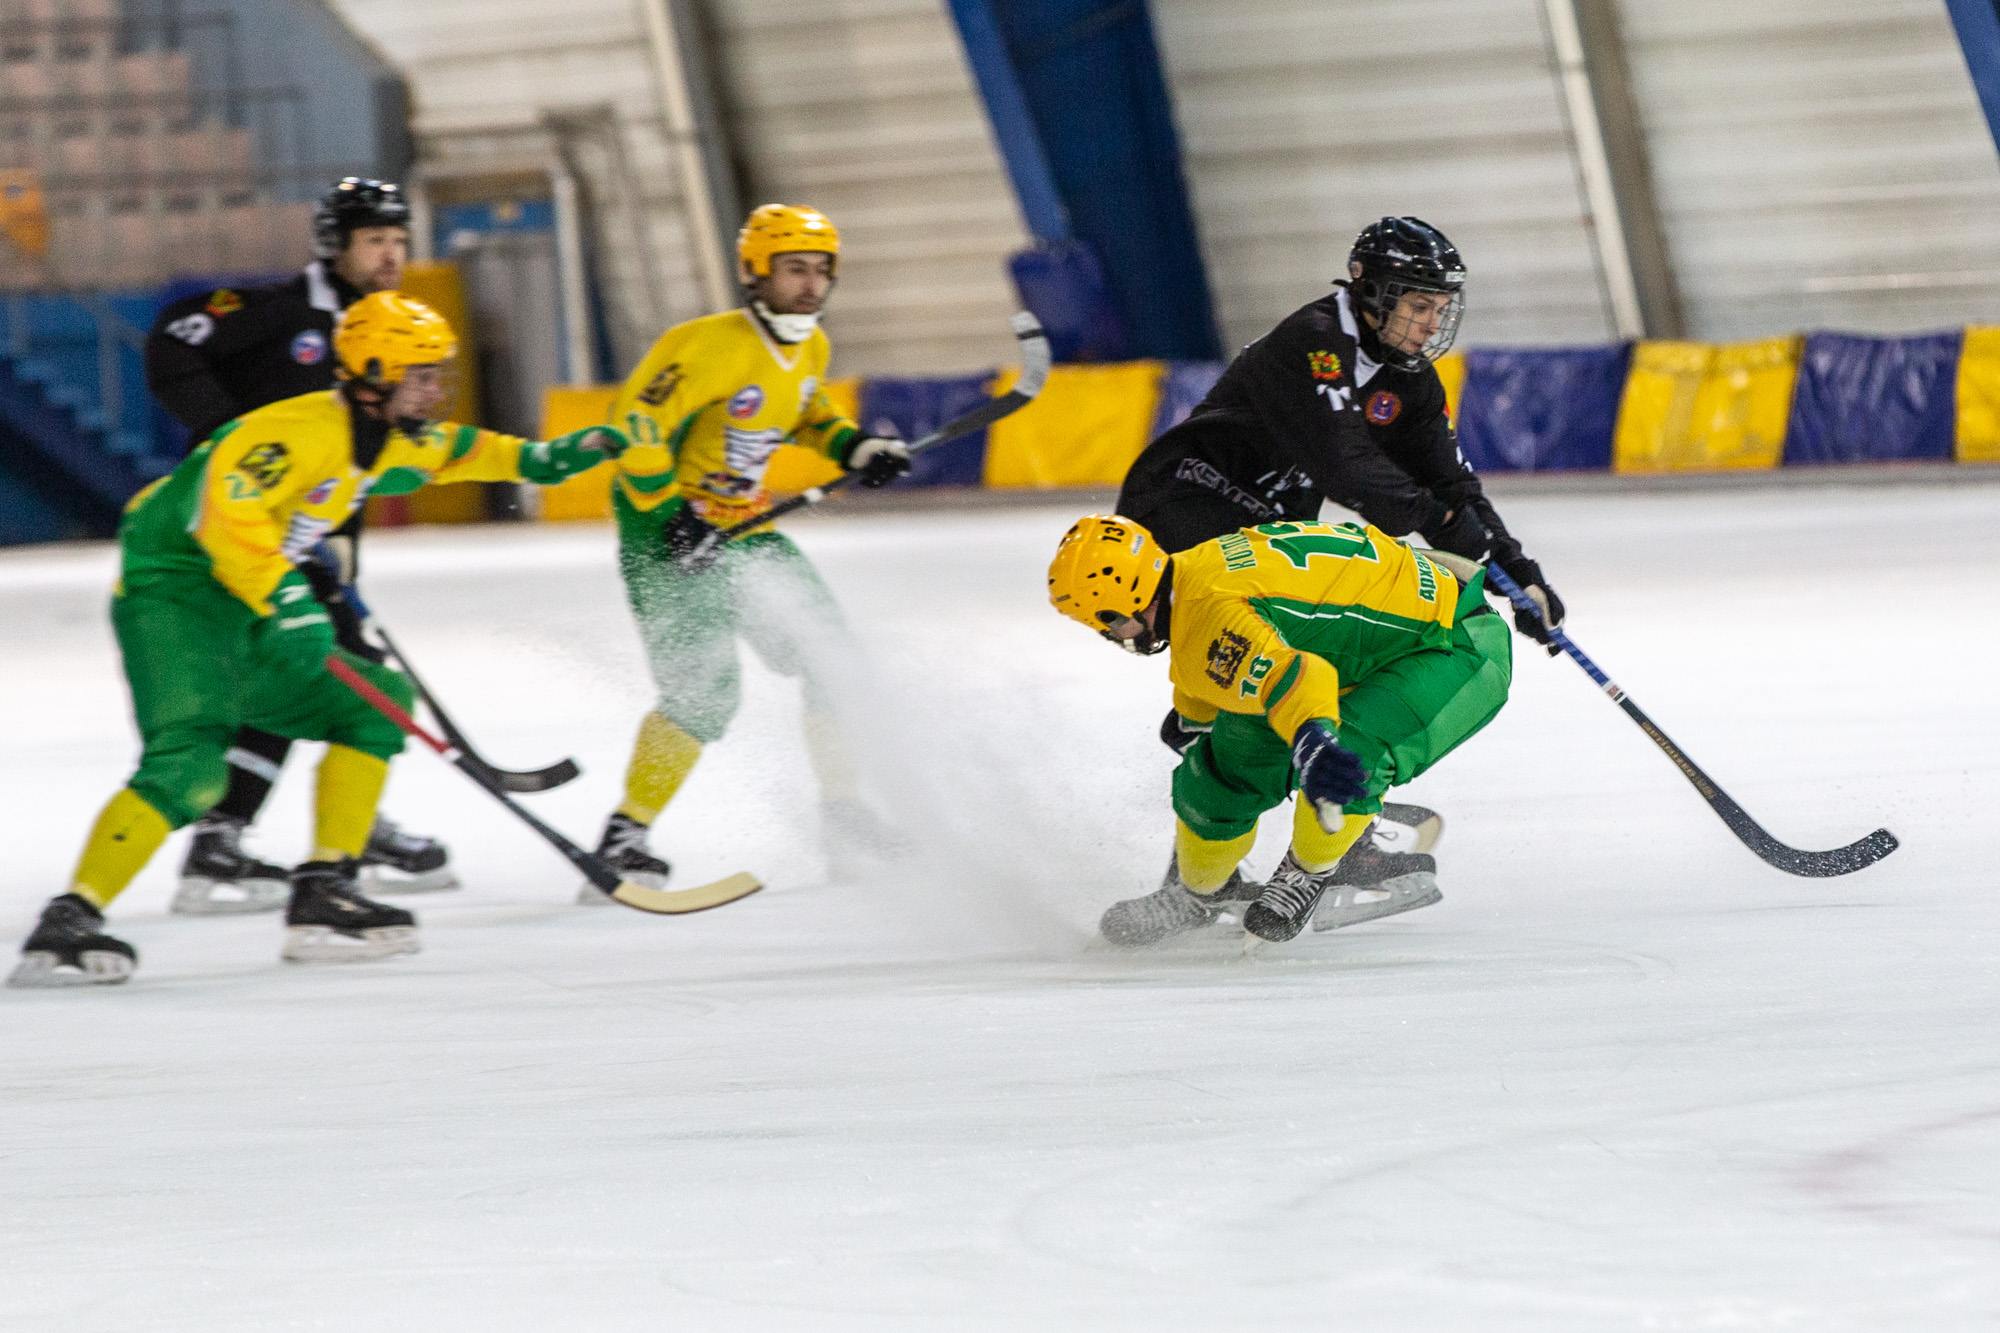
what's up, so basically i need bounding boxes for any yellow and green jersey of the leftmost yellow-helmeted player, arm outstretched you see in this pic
[118,390,576,614]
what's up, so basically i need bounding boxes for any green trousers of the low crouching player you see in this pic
[1174,602,1514,843]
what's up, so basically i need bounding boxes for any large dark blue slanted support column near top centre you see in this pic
[950,0,1222,360]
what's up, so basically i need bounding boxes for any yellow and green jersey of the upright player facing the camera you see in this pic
[612,308,860,536]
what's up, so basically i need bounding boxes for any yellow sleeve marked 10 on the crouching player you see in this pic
[1170,596,1340,743]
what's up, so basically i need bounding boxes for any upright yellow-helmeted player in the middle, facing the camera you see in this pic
[578,204,910,892]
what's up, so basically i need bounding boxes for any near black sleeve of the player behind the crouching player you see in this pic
[1244,306,1444,536]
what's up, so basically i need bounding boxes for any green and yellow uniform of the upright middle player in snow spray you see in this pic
[612,308,860,825]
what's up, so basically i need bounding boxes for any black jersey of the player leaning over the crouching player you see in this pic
[1118,288,1520,562]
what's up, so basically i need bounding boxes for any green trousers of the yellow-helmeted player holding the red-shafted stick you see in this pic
[112,578,414,829]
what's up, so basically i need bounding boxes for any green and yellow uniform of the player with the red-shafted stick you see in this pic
[72,390,600,907]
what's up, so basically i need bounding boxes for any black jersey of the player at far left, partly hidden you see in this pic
[146,260,360,442]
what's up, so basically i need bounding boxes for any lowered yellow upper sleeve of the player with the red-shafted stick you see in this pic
[194,430,310,616]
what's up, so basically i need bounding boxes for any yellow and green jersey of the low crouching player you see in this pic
[1168,522,1462,741]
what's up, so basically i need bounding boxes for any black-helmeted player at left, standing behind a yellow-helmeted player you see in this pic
[146,176,458,913]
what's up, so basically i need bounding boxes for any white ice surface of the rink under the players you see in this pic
[0,472,2000,1333]
